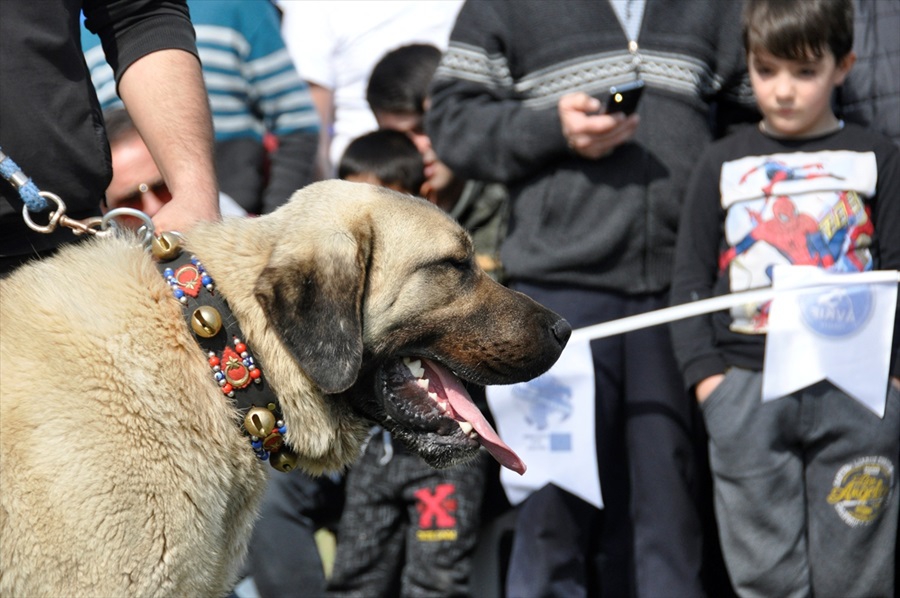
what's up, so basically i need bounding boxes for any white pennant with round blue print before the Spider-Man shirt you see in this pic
[762,266,898,417]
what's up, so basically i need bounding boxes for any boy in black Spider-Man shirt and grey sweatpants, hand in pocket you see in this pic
[672,0,900,597]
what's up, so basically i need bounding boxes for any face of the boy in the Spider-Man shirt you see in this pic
[747,49,855,137]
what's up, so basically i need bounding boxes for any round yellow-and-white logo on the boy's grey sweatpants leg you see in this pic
[828,457,894,527]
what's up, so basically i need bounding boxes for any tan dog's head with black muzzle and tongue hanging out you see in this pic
[206,181,571,472]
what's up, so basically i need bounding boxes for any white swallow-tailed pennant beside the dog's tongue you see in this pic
[487,339,603,508]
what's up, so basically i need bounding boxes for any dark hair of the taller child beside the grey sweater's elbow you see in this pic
[366,44,441,114]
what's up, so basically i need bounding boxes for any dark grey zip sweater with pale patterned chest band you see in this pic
[427,0,756,294]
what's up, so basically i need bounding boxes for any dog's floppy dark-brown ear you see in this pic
[254,220,370,394]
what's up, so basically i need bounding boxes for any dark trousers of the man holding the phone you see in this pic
[507,284,708,598]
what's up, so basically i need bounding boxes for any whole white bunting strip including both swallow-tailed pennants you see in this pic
[487,266,900,508]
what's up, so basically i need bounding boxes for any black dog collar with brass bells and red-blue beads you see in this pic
[152,233,297,472]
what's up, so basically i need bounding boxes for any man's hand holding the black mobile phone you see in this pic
[558,92,640,160]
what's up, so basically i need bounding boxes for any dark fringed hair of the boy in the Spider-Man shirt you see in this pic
[743,0,853,62]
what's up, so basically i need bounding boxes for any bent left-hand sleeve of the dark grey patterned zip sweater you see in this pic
[425,2,568,184]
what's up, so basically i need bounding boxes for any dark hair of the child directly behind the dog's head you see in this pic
[338,129,425,195]
